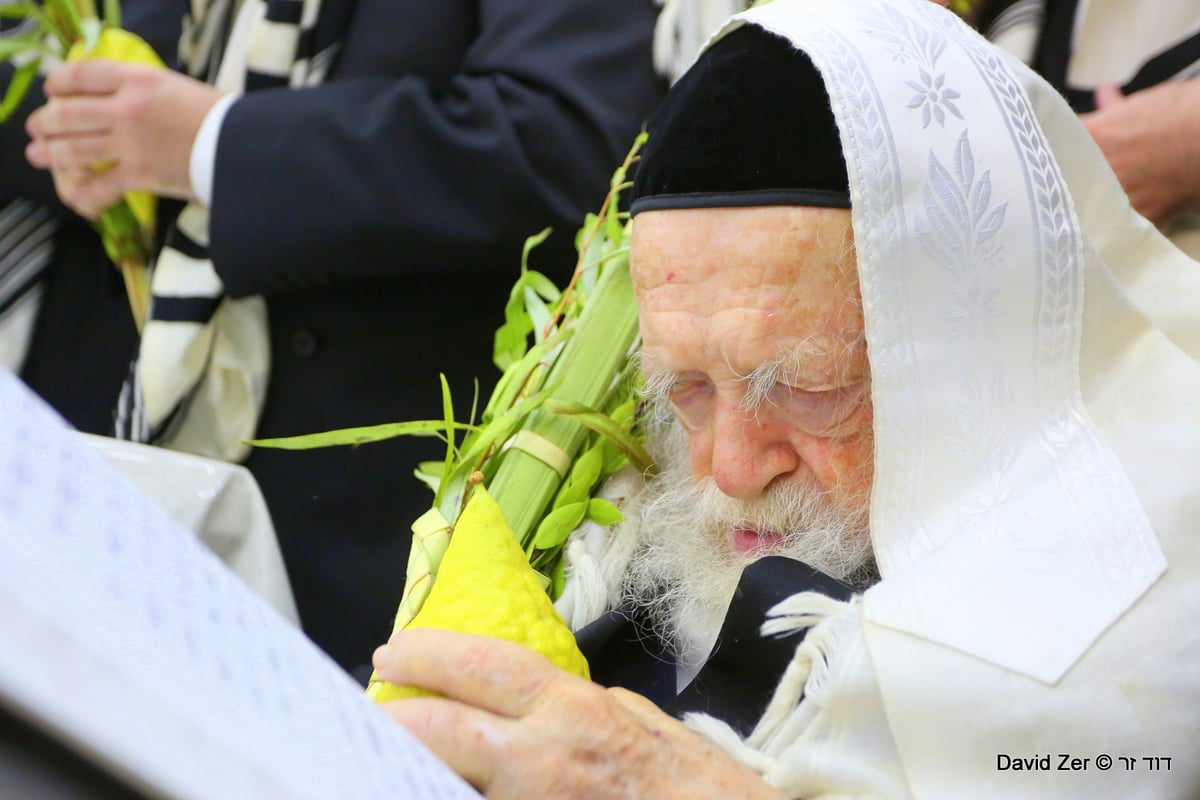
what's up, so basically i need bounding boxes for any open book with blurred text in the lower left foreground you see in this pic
[0,371,479,800]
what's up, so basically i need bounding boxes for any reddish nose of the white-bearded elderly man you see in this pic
[709,401,802,500]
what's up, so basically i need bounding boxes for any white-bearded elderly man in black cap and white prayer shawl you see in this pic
[376,0,1200,799]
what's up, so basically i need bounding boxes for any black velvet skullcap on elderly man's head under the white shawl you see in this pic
[631,24,850,213]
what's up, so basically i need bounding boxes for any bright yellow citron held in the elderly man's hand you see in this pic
[371,486,589,703]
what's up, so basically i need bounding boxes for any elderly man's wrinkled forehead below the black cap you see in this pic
[630,206,865,381]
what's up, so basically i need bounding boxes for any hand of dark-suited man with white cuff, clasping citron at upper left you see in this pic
[25,59,222,219]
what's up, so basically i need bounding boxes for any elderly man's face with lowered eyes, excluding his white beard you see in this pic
[631,207,872,557]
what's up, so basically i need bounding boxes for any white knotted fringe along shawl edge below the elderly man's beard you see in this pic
[684,591,858,798]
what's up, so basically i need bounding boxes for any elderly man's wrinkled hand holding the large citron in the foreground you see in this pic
[374,630,782,800]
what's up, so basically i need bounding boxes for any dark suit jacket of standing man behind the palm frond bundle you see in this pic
[0,0,665,670]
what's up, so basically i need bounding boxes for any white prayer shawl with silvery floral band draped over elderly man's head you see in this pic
[648,0,1200,800]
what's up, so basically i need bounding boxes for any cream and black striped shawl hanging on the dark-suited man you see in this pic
[116,0,320,462]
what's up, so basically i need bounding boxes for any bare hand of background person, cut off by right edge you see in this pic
[1080,80,1200,225]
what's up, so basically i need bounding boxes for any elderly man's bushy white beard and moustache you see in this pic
[622,421,875,670]
